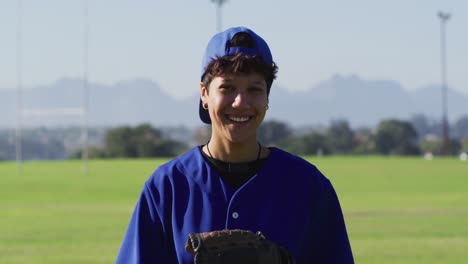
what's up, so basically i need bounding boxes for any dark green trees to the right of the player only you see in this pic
[259,119,468,155]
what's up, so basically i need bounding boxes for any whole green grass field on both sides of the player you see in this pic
[0,157,468,264]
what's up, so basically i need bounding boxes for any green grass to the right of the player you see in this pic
[309,157,468,264]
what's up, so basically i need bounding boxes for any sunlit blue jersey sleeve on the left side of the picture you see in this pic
[116,184,168,264]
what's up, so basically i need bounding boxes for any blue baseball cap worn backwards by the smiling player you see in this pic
[199,27,273,124]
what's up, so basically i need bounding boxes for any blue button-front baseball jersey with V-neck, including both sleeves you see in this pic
[117,147,354,264]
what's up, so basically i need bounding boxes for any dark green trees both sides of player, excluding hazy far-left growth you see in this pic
[85,118,468,158]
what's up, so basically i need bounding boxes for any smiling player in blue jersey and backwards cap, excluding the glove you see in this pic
[117,27,353,264]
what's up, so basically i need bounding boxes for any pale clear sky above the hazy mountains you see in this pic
[0,0,468,98]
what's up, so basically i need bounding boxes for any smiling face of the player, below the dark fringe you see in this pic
[200,73,268,143]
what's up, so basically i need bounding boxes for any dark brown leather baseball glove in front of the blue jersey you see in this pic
[185,229,295,264]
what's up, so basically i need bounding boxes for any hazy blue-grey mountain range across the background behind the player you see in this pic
[0,75,468,128]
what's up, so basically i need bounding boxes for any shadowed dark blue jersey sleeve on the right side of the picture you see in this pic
[320,181,354,264]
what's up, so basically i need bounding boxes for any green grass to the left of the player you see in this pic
[0,160,161,263]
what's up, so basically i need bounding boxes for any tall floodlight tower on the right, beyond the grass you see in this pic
[438,11,450,155]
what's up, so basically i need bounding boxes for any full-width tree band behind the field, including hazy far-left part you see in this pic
[0,115,468,160]
